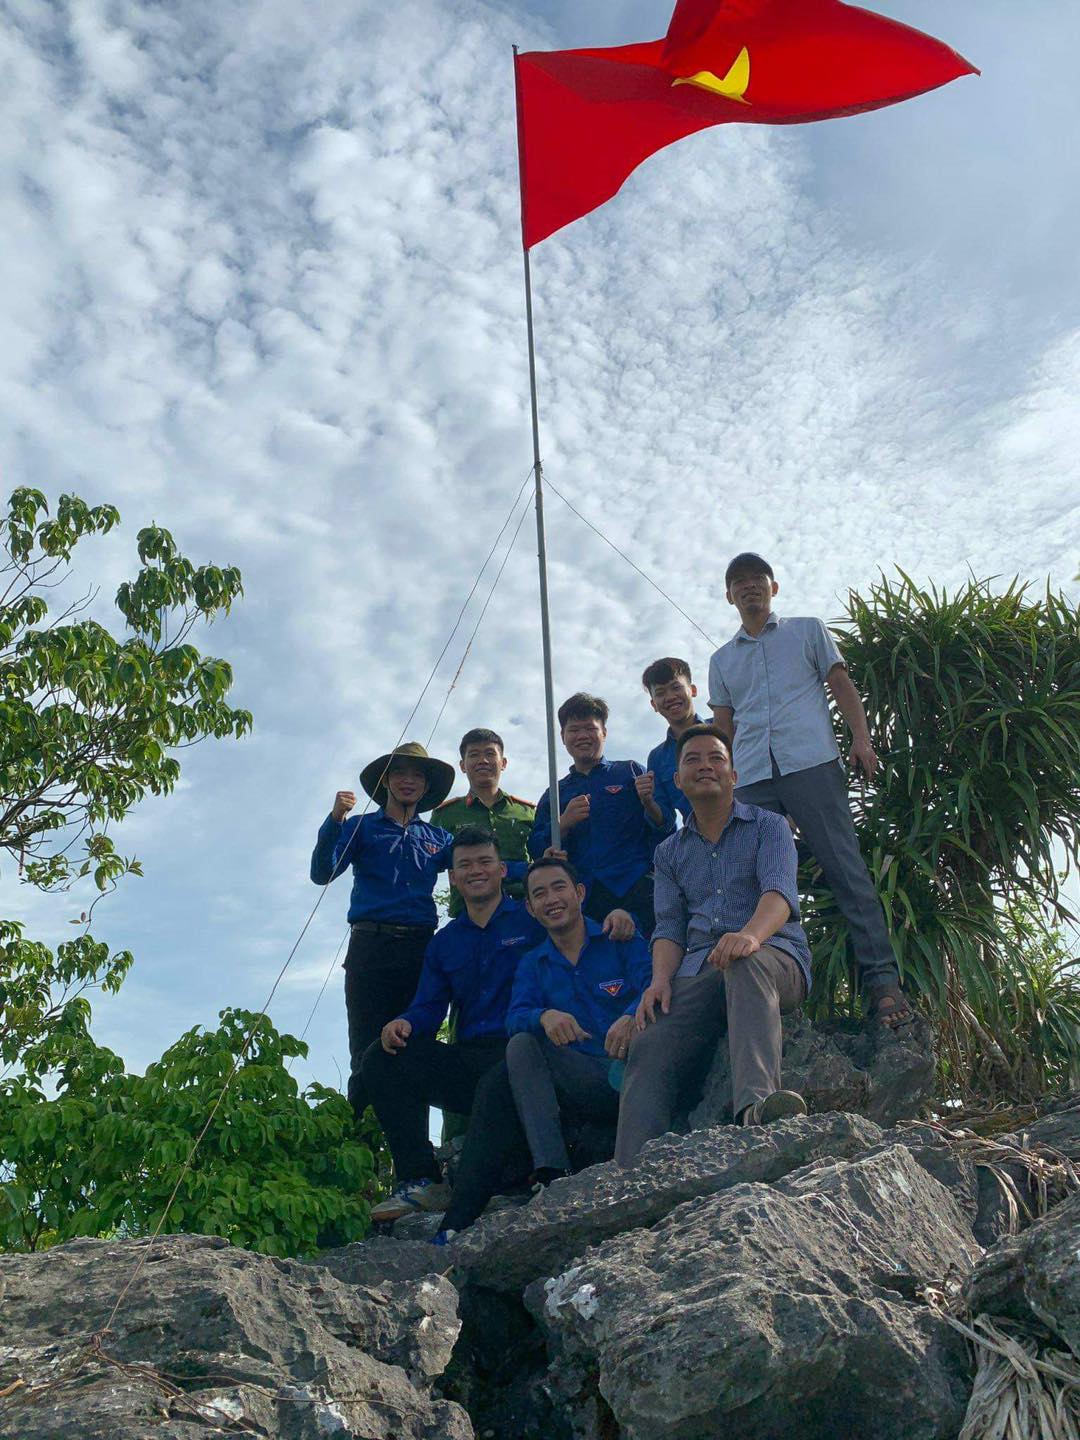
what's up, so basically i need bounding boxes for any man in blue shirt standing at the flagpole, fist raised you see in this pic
[528,694,675,936]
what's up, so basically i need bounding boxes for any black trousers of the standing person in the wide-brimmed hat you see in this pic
[344,927,435,1120]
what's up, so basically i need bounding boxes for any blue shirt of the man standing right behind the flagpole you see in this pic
[528,760,675,896]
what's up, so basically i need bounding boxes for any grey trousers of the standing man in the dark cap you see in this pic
[734,760,900,989]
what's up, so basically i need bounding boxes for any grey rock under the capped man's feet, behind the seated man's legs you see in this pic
[690,1015,935,1129]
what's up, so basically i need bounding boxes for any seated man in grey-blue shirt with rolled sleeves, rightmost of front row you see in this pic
[615,726,811,1165]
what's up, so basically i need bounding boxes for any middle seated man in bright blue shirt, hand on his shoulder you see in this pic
[435,858,649,1244]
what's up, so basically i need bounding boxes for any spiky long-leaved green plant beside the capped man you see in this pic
[805,572,1080,1097]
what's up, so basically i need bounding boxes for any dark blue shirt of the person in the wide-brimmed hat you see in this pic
[311,809,454,929]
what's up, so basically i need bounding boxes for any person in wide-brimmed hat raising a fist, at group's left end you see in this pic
[311,740,455,1119]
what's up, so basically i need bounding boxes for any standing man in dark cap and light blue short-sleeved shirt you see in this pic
[708,553,912,1028]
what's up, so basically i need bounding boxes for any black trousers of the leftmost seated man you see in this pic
[361,1035,507,1185]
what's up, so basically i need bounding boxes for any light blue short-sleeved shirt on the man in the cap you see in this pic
[708,615,844,785]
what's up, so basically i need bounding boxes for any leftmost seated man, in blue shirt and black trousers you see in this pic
[363,825,544,1221]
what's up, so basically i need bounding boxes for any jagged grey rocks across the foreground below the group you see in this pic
[0,1088,1080,1440]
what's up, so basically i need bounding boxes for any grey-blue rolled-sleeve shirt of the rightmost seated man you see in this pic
[652,801,811,994]
